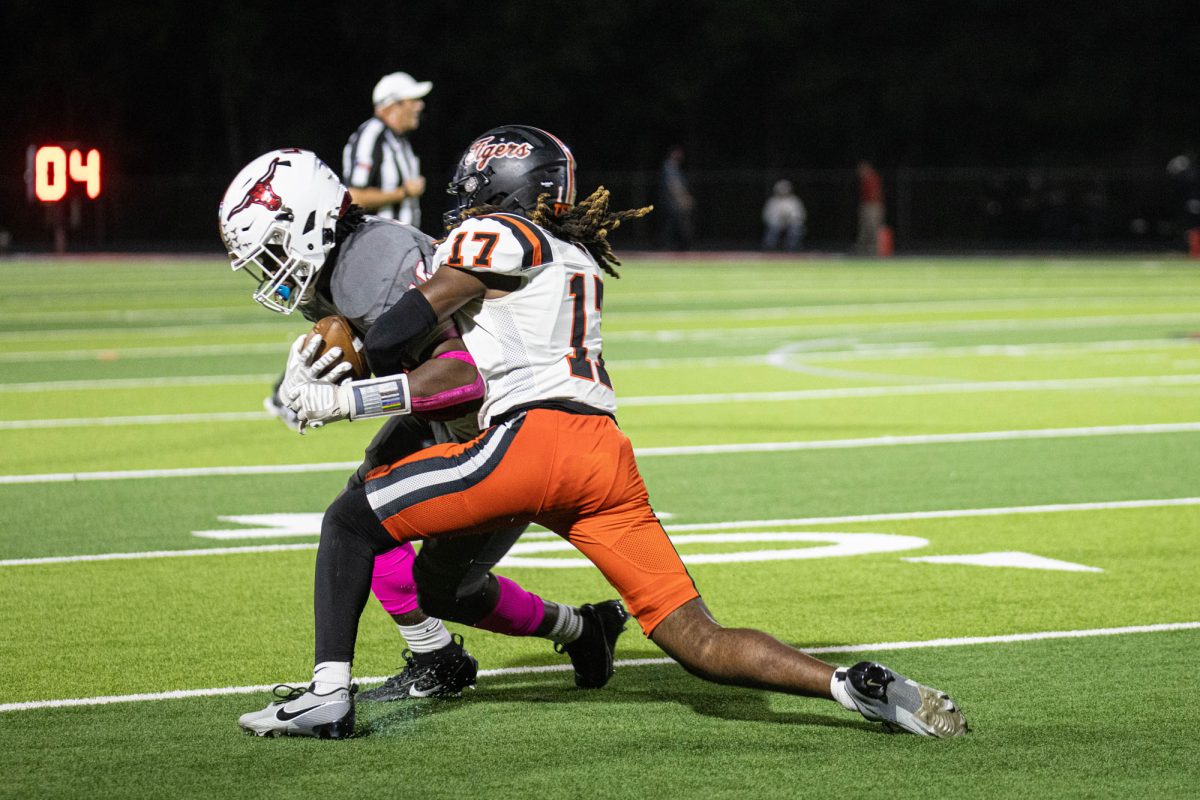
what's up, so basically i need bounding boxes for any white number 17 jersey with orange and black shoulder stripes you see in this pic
[433,213,617,426]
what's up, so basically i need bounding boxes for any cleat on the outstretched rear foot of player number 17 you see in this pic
[835,661,968,739]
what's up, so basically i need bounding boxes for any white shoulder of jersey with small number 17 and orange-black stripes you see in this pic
[433,213,554,275]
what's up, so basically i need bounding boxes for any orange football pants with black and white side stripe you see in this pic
[366,409,700,636]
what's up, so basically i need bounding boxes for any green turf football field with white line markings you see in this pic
[0,259,1200,800]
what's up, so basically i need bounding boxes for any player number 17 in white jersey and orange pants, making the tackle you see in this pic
[259,126,967,738]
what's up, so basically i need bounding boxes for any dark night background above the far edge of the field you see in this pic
[0,0,1200,252]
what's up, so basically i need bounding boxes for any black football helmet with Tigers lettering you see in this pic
[445,125,575,228]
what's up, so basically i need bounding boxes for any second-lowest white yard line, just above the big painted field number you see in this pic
[0,498,1200,567]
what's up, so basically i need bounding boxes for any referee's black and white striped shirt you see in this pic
[342,116,421,227]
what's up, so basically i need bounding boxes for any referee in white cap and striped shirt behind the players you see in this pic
[342,72,433,228]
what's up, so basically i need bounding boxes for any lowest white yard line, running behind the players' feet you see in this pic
[0,622,1200,712]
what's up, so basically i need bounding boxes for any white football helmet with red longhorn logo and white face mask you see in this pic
[218,149,350,314]
